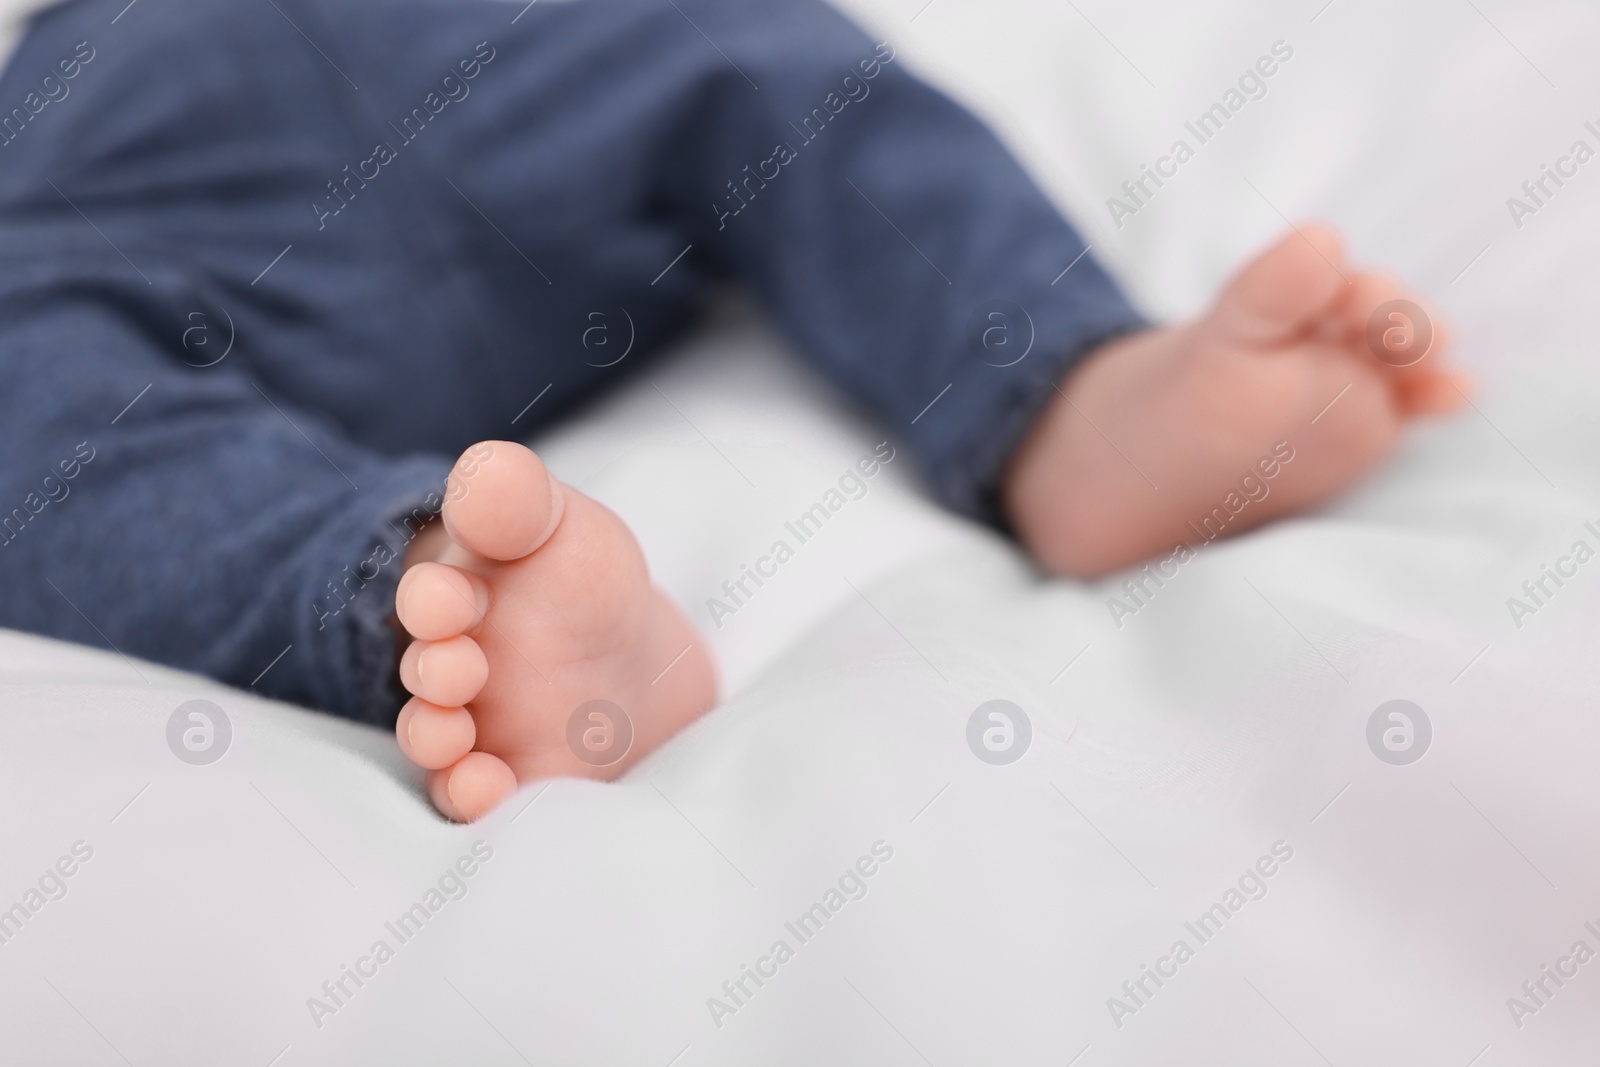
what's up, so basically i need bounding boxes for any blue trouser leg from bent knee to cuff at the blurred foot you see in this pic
[636,2,1146,522]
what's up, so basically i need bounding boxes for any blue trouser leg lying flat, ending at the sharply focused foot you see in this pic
[0,255,450,723]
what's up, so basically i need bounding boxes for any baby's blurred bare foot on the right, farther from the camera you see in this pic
[1002,226,1467,576]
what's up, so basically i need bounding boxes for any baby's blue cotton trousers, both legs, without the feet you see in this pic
[0,0,1141,723]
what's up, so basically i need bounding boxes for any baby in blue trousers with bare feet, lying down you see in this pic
[0,0,1464,821]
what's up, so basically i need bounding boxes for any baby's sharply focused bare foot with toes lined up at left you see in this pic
[395,442,715,821]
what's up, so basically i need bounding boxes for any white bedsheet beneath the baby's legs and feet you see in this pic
[0,0,1600,1067]
